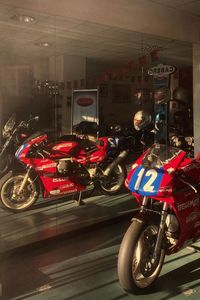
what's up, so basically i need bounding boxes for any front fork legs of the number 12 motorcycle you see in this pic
[141,196,169,260]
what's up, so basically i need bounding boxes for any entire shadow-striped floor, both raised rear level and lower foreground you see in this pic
[0,184,200,300]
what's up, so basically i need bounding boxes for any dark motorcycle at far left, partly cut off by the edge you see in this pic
[0,113,39,176]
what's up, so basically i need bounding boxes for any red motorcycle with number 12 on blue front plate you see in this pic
[118,144,200,292]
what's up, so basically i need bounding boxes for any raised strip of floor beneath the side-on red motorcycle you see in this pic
[0,193,138,253]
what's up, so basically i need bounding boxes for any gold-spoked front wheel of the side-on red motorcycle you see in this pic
[0,173,39,212]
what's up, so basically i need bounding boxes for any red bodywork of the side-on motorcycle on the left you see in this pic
[16,133,115,198]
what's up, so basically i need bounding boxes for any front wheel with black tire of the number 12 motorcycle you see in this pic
[118,220,165,293]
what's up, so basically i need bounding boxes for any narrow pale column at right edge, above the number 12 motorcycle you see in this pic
[193,44,200,154]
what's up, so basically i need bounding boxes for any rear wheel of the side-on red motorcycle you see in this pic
[98,164,127,195]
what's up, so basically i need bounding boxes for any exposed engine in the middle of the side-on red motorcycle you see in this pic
[57,157,90,185]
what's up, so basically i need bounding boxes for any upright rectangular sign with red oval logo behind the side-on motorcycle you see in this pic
[71,89,99,133]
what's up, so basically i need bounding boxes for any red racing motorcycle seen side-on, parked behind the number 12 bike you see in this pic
[0,132,128,212]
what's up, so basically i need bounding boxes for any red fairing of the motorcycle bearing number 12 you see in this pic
[125,144,200,252]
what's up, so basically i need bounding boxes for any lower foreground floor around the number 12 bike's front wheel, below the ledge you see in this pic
[0,219,200,300]
